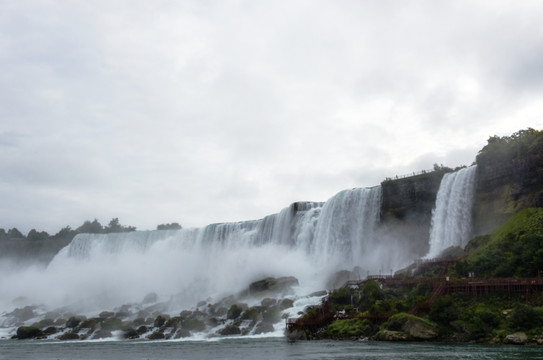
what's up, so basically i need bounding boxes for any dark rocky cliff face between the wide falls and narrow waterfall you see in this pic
[381,170,445,256]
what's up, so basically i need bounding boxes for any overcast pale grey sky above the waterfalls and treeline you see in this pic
[0,0,543,234]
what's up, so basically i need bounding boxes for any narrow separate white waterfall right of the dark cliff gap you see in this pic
[426,165,477,258]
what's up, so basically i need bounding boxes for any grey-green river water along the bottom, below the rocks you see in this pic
[0,338,543,360]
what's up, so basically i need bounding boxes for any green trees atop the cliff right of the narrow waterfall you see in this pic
[477,128,543,164]
